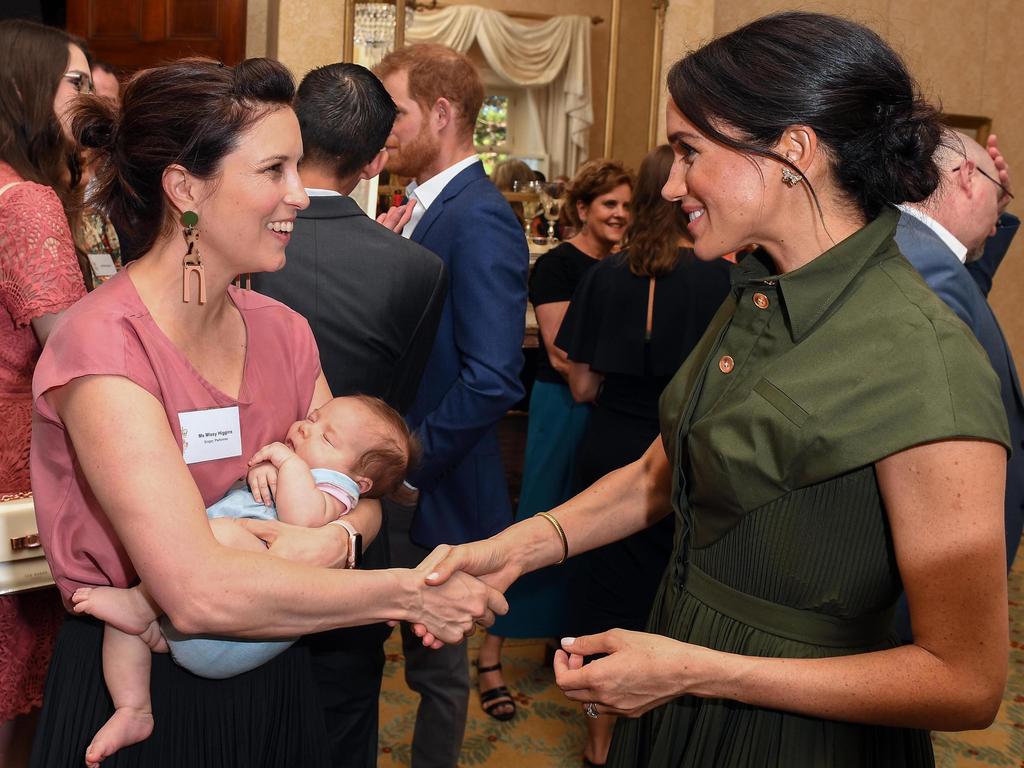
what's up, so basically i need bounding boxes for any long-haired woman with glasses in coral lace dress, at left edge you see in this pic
[0,22,90,766]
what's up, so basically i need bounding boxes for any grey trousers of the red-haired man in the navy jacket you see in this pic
[385,502,469,768]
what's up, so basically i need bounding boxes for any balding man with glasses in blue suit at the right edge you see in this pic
[896,131,1024,637]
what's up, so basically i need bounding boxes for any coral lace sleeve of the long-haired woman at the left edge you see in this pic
[0,182,85,328]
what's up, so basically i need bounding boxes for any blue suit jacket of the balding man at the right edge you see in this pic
[896,214,1024,569]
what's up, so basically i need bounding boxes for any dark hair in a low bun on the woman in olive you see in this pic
[669,11,941,218]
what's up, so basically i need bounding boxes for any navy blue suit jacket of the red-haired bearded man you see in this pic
[408,163,529,547]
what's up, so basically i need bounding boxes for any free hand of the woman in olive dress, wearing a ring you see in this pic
[555,630,715,717]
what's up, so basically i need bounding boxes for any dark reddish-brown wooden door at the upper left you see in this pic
[68,0,246,72]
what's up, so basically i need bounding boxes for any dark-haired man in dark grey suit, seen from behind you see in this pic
[253,63,447,768]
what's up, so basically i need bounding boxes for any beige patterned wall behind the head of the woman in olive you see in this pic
[659,0,1024,374]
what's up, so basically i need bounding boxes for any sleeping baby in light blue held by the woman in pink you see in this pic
[72,395,419,768]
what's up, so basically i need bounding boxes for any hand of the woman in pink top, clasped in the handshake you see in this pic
[403,545,509,648]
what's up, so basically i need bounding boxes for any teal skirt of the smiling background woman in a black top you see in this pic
[489,381,590,638]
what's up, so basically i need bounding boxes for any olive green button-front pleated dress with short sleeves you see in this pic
[609,209,1009,768]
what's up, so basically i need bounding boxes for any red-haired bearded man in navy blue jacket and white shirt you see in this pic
[376,44,529,768]
